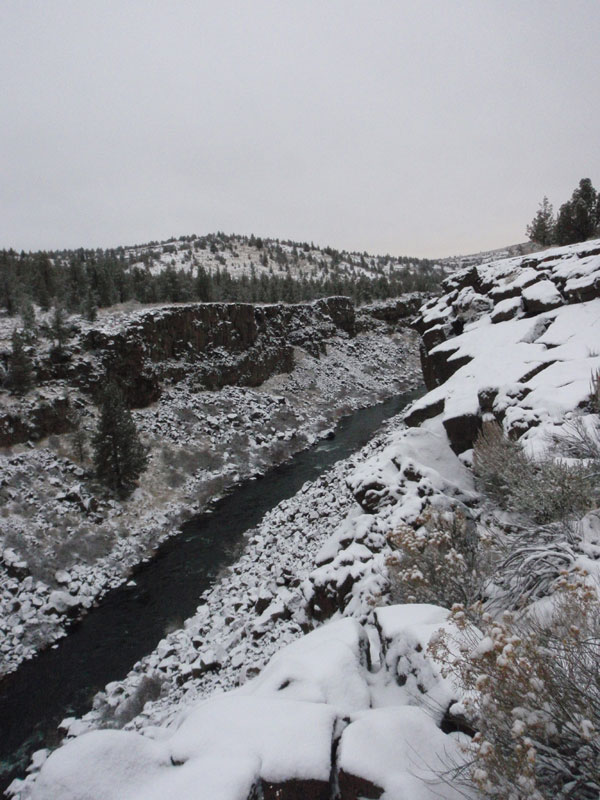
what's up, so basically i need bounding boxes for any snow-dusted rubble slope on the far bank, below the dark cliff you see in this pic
[0,329,420,674]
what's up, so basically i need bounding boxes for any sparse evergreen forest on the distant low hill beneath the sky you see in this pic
[0,234,443,321]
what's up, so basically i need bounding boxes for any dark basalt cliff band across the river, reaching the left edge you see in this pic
[0,297,355,447]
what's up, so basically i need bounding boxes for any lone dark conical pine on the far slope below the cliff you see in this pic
[92,383,148,494]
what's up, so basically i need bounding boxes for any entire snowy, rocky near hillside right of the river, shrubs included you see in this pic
[13,240,600,800]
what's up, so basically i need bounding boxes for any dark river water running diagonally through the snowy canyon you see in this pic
[0,391,421,791]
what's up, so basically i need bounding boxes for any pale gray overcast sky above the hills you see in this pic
[0,0,600,257]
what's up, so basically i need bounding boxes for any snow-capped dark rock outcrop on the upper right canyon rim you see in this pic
[414,236,600,453]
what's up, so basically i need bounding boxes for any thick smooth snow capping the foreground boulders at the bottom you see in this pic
[24,607,458,800]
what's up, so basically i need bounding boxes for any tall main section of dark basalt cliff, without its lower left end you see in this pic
[83,297,354,407]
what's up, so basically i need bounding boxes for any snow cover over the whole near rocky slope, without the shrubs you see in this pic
[10,242,600,800]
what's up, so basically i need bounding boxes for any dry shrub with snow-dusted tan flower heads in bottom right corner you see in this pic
[430,572,600,800]
